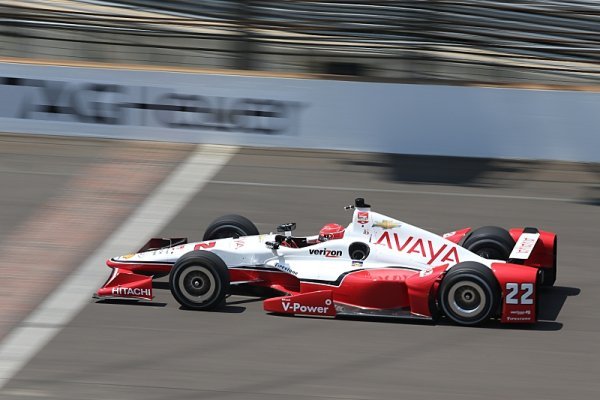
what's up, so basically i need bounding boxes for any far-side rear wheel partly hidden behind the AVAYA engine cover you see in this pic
[463,226,516,261]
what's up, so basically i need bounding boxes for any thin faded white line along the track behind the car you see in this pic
[210,181,577,203]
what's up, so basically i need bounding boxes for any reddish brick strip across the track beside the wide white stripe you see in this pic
[0,141,188,342]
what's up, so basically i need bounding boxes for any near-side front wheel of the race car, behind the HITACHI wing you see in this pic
[169,250,229,310]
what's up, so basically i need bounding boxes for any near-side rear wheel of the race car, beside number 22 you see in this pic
[438,261,500,326]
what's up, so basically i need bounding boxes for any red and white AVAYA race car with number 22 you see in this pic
[96,198,557,326]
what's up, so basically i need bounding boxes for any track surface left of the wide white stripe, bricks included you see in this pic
[0,134,194,340]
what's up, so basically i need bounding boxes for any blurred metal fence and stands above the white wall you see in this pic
[0,0,600,84]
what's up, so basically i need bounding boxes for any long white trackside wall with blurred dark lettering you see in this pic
[0,63,600,162]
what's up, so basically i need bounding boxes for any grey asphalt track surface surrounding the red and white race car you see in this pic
[0,137,600,400]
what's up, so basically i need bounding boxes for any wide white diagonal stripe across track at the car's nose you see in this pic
[0,145,237,389]
